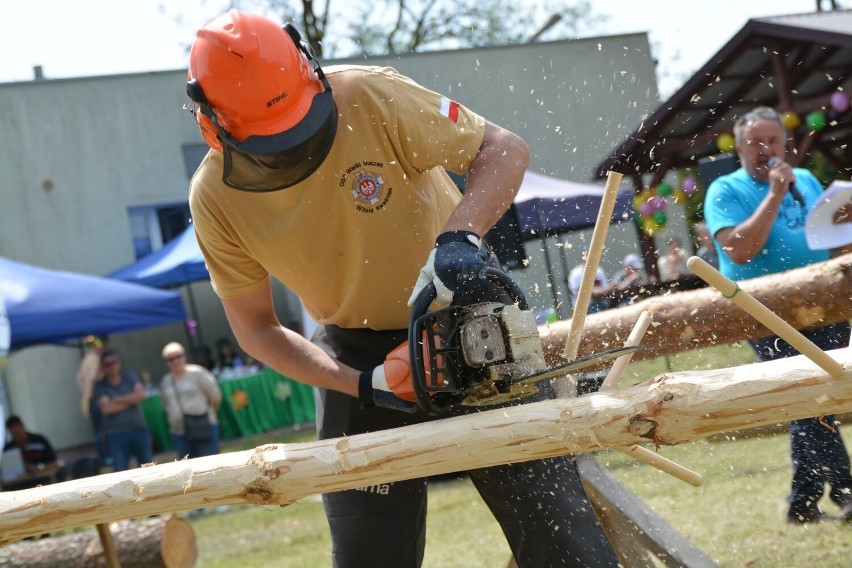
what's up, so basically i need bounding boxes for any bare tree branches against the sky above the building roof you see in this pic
[231,0,601,57]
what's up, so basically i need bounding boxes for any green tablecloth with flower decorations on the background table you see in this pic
[142,370,316,452]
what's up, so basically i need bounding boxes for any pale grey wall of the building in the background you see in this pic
[0,34,658,448]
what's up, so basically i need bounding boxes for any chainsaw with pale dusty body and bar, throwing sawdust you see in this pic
[408,268,640,415]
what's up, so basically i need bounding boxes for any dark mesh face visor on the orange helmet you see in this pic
[217,89,337,192]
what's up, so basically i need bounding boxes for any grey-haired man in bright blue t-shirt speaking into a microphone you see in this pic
[704,107,852,523]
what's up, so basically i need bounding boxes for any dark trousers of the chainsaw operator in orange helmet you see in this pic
[313,326,618,568]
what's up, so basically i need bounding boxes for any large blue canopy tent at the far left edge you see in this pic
[0,257,186,351]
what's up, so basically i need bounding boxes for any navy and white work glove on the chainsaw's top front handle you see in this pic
[408,231,487,307]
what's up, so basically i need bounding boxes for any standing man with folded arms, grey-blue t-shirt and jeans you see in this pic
[92,349,154,471]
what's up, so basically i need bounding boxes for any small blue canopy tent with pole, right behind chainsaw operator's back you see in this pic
[106,224,210,347]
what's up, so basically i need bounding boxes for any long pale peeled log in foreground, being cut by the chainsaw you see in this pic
[0,348,852,545]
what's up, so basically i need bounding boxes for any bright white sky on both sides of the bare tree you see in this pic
[0,0,836,97]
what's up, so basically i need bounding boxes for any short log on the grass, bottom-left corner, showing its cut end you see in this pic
[0,516,198,568]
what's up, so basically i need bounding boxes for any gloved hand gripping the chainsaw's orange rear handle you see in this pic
[358,341,417,412]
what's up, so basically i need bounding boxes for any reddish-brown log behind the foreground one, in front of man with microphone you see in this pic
[540,254,852,364]
